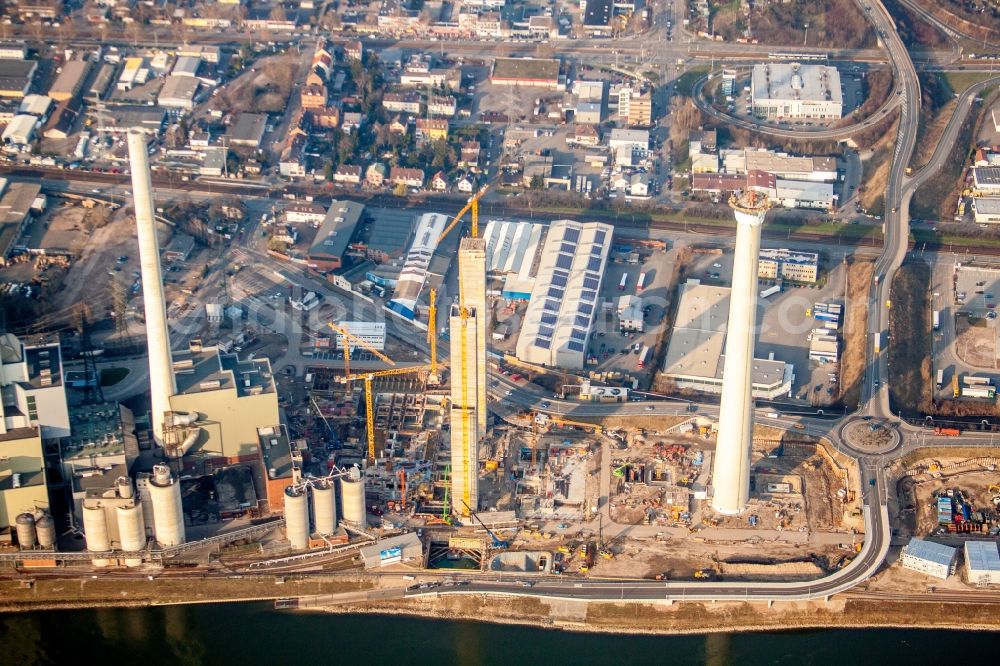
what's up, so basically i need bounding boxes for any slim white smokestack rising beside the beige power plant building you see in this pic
[128,128,177,446]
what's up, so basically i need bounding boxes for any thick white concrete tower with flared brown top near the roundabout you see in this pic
[712,191,771,515]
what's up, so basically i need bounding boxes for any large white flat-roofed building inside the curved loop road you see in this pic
[750,63,844,120]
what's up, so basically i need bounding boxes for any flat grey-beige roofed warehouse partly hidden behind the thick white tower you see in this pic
[663,279,794,399]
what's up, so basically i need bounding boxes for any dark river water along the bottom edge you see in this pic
[0,603,1000,666]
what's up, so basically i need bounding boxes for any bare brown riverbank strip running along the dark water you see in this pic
[0,576,1000,635]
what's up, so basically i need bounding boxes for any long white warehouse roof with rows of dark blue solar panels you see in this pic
[516,220,614,370]
